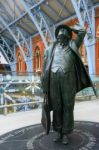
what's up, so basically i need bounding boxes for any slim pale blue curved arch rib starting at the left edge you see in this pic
[0,16,26,61]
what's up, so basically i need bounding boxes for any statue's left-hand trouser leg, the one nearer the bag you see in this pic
[50,72,62,132]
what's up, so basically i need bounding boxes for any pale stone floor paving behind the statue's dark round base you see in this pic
[0,100,99,135]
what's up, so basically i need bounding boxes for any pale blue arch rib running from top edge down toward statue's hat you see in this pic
[21,0,53,48]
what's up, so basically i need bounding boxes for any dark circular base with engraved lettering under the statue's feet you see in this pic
[0,122,99,150]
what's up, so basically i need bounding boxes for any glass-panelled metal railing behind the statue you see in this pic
[0,73,99,114]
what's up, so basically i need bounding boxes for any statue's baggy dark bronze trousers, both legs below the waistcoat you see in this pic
[50,72,76,134]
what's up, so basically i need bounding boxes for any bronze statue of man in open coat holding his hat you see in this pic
[42,25,95,144]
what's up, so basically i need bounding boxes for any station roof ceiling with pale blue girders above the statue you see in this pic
[0,0,99,75]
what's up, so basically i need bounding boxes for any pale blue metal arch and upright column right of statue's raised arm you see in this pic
[71,0,95,75]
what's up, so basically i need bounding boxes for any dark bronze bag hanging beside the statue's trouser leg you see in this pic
[41,95,51,134]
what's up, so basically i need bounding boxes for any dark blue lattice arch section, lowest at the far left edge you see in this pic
[0,37,14,62]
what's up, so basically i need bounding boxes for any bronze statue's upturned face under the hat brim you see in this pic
[57,29,70,44]
